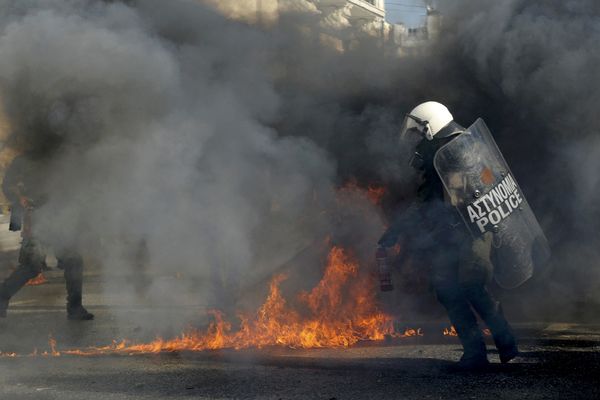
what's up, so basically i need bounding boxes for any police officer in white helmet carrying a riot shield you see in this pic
[378,102,545,368]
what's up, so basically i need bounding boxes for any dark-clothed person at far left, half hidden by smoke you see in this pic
[0,152,94,320]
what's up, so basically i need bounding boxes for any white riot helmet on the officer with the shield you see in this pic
[400,101,454,140]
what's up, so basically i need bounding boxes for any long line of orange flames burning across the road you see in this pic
[0,247,422,356]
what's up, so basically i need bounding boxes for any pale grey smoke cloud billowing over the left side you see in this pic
[0,0,381,322]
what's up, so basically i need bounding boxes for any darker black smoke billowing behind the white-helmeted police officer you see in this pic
[264,0,600,318]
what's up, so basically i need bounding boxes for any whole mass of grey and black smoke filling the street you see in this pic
[0,0,600,326]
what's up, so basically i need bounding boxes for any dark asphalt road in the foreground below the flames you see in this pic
[0,324,600,399]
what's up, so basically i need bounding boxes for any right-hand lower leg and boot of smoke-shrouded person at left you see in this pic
[59,255,94,321]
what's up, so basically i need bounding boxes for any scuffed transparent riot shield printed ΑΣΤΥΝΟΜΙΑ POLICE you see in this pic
[434,119,550,289]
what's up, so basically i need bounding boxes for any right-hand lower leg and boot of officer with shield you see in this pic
[465,286,519,364]
